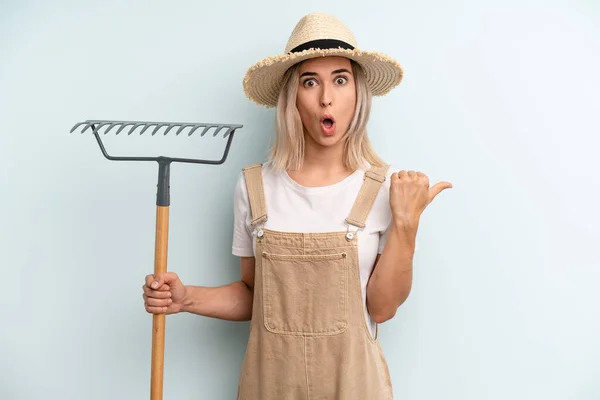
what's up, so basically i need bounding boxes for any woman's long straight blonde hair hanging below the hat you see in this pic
[268,60,384,170]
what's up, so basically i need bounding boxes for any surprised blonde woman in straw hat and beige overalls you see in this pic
[144,13,451,400]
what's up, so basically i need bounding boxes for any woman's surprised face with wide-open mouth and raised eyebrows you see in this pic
[296,57,356,146]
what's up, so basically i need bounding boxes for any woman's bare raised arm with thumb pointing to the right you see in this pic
[367,171,452,323]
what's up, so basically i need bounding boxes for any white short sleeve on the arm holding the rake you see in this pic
[231,173,254,257]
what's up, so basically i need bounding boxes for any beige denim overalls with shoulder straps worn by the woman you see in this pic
[237,164,392,400]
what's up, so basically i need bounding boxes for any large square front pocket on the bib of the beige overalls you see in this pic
[261,252,348,336]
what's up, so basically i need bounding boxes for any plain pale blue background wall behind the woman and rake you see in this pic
[0,0,600,400]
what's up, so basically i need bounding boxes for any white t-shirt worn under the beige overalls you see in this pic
[232,163,395,337]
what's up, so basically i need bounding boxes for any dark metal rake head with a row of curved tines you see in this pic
[70,120,243,164]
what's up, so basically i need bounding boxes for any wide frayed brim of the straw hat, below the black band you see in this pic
[243,48,404,107]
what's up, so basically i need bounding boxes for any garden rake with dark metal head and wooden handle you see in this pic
[71,120,243,400]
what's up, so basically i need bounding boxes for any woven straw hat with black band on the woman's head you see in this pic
[243,13,403,107]
